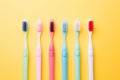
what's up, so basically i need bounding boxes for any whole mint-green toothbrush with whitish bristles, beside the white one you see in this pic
[74,19,80,80]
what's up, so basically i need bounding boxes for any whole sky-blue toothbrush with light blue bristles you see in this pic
[62,20,68,80]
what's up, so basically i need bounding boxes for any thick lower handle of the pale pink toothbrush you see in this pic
[36,49,41,80]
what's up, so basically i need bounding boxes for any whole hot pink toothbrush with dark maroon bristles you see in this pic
[49,20,55,80]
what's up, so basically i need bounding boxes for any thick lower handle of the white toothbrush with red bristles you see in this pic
[88,50,94,80]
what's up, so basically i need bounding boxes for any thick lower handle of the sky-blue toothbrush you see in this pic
[62,50,68,80]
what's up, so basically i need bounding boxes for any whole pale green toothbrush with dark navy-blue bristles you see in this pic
[22,20,28,80]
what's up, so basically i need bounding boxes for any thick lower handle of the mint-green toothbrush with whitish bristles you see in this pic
[75,50,80,80]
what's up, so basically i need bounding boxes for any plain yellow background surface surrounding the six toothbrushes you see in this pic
[0,0,120,80]
